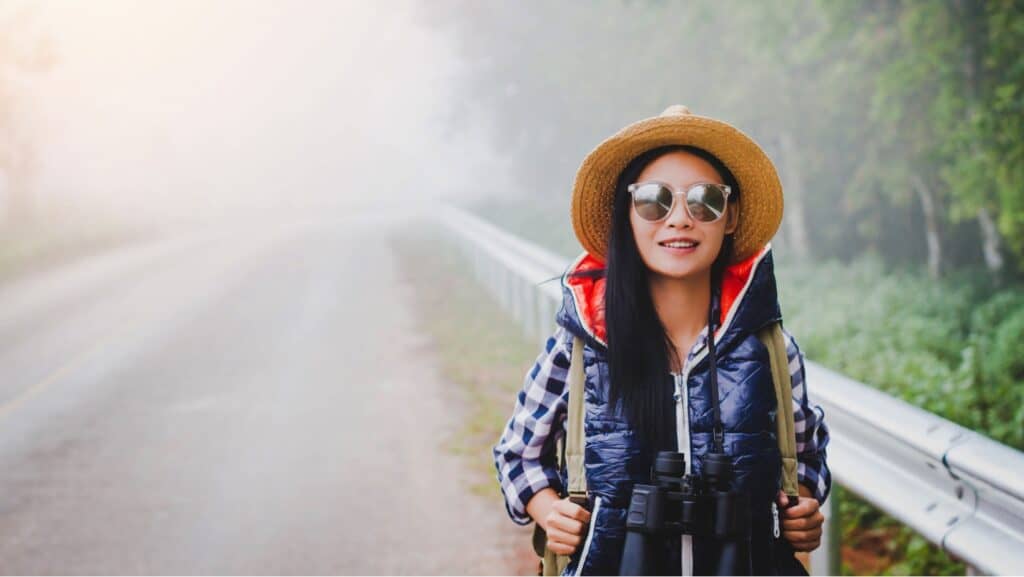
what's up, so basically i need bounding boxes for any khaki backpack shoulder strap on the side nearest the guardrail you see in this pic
[758,323,799,502]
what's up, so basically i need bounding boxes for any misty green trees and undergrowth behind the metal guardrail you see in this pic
[429,0,1024,574]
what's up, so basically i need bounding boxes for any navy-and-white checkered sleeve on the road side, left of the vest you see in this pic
[494,327,572,525]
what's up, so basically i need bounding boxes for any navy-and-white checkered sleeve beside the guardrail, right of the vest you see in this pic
[782,330,831,503]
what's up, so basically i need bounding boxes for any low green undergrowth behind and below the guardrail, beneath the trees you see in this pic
[776,256,1024,575]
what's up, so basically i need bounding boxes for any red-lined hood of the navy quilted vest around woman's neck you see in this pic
[556,244,782,352]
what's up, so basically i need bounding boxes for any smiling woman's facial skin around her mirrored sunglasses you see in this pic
[630,151,739,279]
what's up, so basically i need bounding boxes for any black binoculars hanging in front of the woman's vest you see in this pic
[618,451,752,575]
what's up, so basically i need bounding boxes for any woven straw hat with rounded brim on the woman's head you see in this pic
[572,105,782,262]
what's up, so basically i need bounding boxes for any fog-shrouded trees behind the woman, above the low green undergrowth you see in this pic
[425,0,1024,282]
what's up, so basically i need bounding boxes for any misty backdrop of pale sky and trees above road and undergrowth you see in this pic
[6,0,1024,281]
